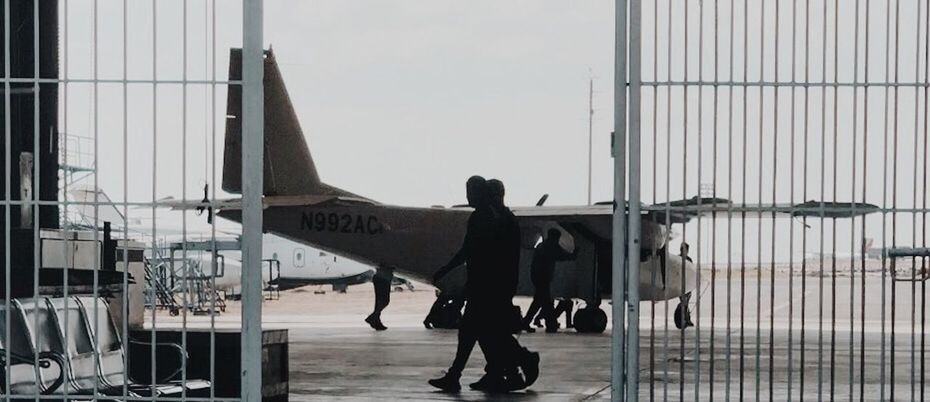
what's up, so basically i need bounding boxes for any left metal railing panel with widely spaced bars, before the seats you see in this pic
[0,0,263,401]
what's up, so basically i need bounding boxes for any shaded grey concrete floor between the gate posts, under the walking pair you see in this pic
[290,327,609,401]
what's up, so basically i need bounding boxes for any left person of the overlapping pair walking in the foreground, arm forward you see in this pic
[429,176,508,392]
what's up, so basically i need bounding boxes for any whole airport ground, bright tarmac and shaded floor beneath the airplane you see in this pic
[158,267,930,401]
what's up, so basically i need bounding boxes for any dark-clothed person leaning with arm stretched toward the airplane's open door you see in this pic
[523,228,577,332]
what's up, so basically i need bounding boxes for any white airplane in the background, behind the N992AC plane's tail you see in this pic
[68,185,374,295]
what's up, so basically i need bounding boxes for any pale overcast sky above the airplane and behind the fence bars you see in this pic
[52,0,927,261]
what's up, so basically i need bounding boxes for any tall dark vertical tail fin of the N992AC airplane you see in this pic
[222,49,358,197]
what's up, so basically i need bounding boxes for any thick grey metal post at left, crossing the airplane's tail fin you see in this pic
[241,0,265,401]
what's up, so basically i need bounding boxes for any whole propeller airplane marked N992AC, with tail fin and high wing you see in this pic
[175,49,878,332]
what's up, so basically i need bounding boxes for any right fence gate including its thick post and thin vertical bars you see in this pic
[610,0,930,402]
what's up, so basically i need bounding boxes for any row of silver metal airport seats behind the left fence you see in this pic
[0,297,210,399]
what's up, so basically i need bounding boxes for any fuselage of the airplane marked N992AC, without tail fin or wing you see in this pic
[220,204,696,301]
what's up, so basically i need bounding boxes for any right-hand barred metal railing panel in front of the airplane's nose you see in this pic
[612,0,930,401]
